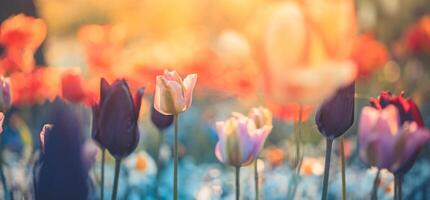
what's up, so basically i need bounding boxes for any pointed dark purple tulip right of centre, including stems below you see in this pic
[315,82,355,200]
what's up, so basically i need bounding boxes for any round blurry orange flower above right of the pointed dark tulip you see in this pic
[351,33,389,78]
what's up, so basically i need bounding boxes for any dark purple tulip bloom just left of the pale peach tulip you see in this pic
[92,79,143,159]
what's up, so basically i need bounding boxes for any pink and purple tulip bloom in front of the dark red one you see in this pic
[358,105,430,174]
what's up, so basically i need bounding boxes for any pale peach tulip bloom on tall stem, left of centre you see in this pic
[154,70,197,115]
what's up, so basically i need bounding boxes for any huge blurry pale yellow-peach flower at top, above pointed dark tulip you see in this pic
[264,0,356,105]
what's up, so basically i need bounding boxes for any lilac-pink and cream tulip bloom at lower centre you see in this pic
[215,113,272,167]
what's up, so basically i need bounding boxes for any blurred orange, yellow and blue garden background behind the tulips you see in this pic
[0,0,430,199]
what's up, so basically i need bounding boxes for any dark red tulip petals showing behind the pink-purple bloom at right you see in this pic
[370,91,424,127]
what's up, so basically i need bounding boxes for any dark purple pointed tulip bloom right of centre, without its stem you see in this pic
[315,82,355,140]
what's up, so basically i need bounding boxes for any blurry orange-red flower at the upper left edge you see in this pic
[0,14,47,74]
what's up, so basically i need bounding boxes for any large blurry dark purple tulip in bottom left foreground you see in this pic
[34,101,90,200]
